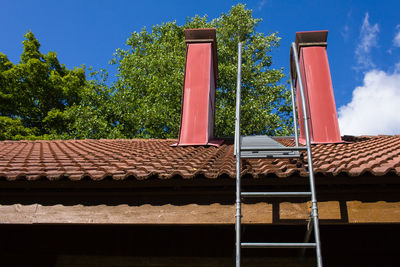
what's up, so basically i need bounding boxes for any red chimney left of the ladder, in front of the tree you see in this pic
[177,29,223,146]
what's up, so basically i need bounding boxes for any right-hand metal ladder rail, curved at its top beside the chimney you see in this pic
[290,42,322,267]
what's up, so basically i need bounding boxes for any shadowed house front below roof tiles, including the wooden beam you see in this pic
[0,177,400,267]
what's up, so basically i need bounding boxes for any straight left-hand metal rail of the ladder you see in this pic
[234,42,242,267]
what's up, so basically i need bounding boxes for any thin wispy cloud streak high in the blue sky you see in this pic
[355,12,379,69]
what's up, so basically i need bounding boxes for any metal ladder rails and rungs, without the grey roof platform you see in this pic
[234,42,322,267]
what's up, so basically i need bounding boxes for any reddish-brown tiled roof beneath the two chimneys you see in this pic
[0,135,400,180]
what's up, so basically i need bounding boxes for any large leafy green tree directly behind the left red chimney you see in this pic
[113,4,291,138]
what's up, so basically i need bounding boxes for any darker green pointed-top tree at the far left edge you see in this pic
[0,31,86,138]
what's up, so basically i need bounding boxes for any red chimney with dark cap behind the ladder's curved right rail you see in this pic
[291,31,342,144]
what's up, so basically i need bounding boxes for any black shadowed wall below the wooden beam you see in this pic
[0,224,400,267]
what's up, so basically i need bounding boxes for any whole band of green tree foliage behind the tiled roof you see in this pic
[0,4,291,140]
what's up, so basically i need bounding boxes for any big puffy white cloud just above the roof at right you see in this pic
[339,68,400,135]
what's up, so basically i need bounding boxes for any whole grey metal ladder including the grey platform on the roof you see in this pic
[234,43,322,267]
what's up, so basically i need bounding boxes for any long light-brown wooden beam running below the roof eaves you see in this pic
[0,201,400,225]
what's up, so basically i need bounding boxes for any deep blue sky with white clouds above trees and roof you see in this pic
[0,0,400,135]
